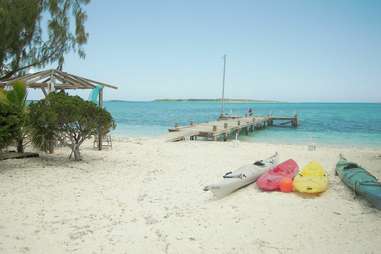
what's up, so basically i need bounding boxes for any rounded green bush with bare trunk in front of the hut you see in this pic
[29,92,115,160]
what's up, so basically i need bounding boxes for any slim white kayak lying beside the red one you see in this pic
[204,153,278,197]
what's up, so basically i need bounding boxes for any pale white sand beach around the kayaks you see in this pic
[0,139,381,254]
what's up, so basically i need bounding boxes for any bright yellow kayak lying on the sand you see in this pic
[293,161,328,193]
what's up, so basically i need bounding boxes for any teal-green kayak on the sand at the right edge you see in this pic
[336,155,381,209]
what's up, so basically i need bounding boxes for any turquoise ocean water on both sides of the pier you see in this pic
[105,101,381,148]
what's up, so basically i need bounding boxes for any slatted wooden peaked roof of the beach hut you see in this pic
[0,69,118,90]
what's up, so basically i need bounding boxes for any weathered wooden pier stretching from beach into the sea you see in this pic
[165,114,298,142]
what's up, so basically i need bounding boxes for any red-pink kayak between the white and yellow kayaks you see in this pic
[257,159,299,191]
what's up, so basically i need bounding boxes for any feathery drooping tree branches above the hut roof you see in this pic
[0,0,90,80]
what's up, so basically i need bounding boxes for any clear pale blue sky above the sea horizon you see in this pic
[29,0,381,102]
